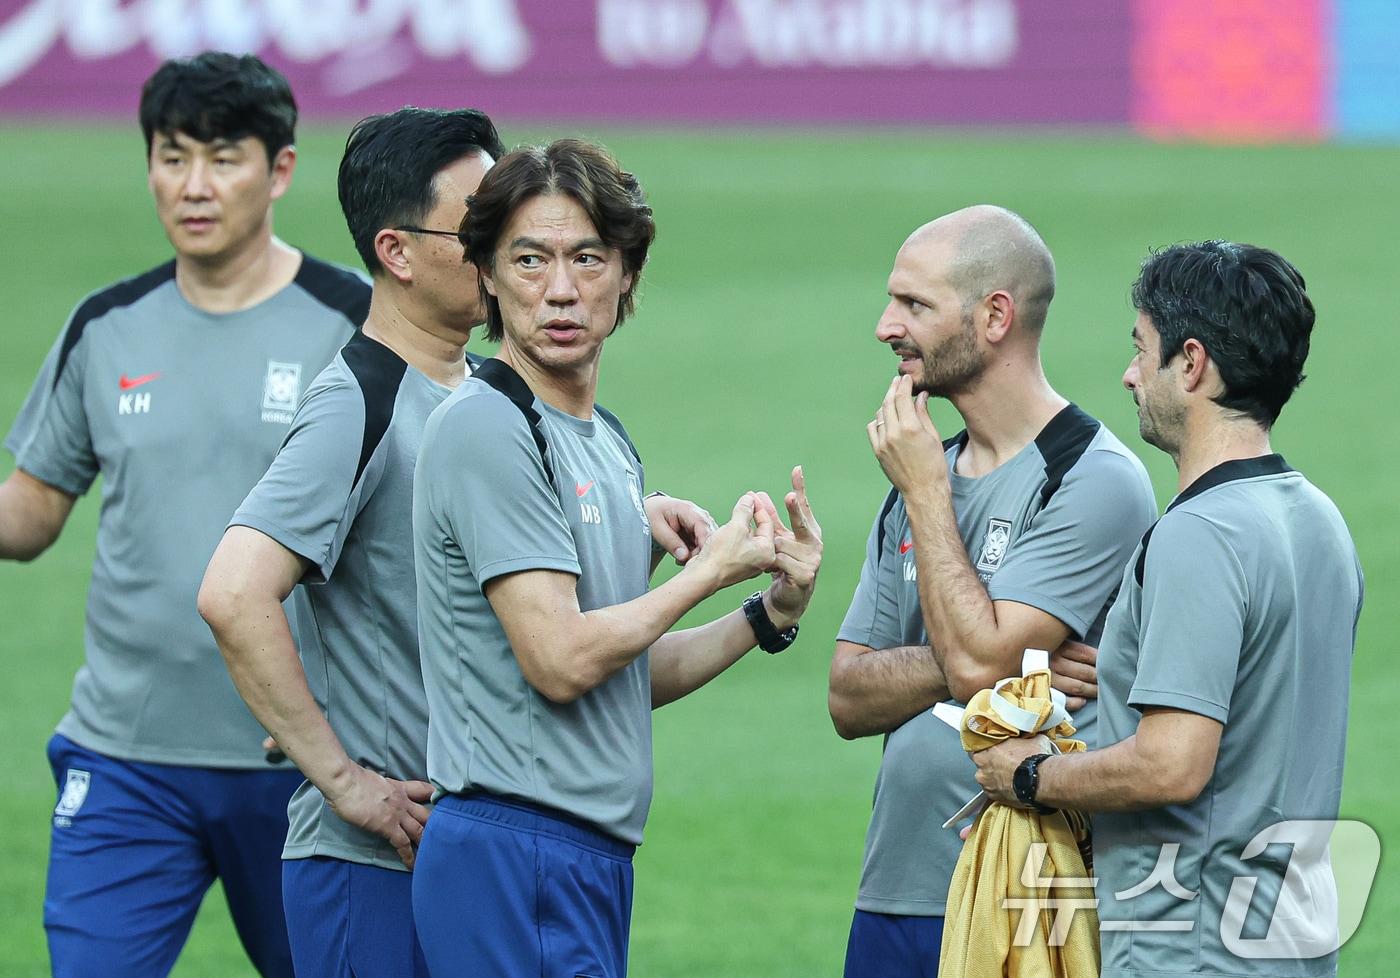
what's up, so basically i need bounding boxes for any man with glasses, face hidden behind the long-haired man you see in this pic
[200,108,707,978]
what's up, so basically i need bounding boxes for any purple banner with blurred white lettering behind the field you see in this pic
[0,0,1133,125]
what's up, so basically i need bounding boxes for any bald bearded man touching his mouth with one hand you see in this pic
[829,206,1156,978]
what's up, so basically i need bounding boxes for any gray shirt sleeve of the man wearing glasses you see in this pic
[230,381,384,583]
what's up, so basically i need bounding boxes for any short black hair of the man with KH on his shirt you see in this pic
[140,50,297,166]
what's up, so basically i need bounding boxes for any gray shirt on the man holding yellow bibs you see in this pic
[1093,455,1362,978]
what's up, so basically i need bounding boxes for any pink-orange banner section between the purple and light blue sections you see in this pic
[1133,0,1331,141]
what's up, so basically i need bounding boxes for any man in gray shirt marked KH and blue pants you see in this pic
[0,53,370,978]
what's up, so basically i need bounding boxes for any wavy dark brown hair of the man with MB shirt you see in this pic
[462,139,657,343]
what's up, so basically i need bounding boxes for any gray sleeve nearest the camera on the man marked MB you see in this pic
[420,392,580,588]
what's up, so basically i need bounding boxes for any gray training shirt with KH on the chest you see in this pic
[6,255,370,770]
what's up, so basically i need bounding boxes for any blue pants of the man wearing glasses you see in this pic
[281,856,428,978]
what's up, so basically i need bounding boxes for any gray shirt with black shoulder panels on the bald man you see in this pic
[837,404,1156,916]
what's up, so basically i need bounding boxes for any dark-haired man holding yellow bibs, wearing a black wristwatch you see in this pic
[974,241,1362,978]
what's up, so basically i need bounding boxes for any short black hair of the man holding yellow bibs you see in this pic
[1133,241,1316,428]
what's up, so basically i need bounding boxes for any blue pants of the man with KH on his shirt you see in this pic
[43,735,302,978]
